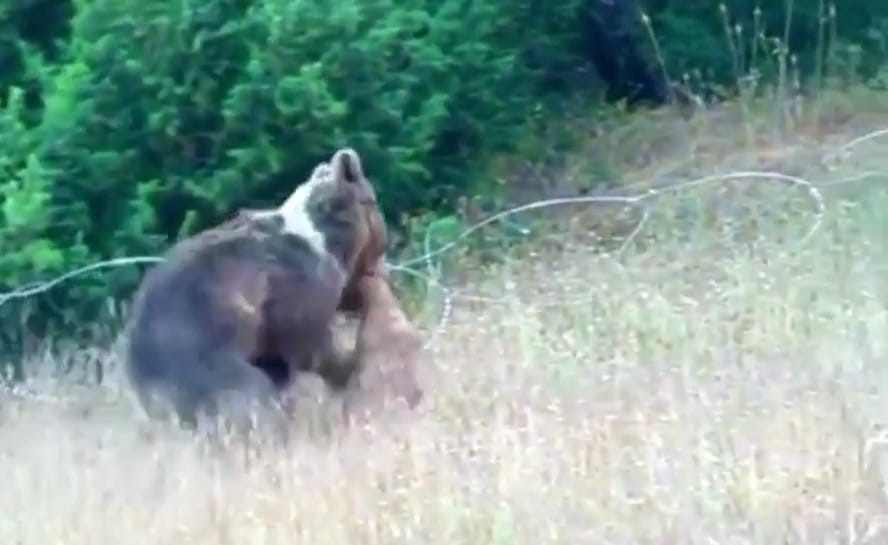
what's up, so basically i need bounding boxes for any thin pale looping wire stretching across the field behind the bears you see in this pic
[0,125,888,398]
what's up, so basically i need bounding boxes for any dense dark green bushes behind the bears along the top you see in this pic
[0,0,888,356]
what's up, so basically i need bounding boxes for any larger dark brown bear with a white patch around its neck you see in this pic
[125,149,385,440]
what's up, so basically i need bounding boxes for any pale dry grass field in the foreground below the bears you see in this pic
[0,100,888,545]
